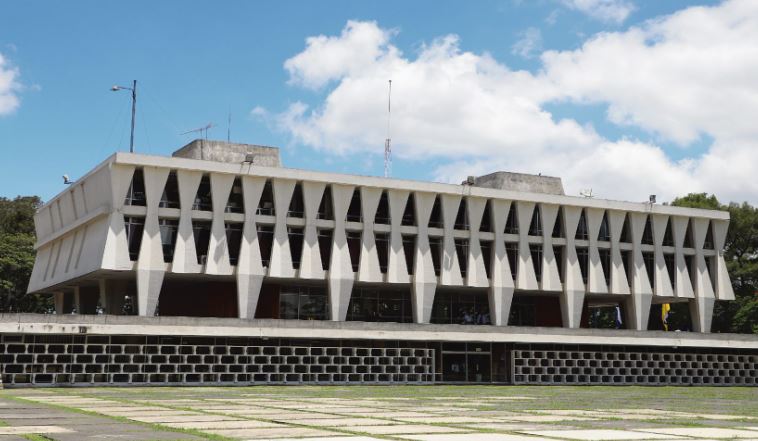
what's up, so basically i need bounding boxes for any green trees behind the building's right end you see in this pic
[671,193,758,334]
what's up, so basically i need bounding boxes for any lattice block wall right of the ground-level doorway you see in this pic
[511,349,758,386]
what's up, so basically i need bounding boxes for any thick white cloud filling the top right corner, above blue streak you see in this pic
[542,0,758,144]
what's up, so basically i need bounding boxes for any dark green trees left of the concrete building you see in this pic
[0,196,52,312]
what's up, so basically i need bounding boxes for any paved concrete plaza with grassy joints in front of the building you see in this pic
[0,386,758,441]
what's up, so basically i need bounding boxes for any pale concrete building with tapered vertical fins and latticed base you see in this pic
[8,140,758,384]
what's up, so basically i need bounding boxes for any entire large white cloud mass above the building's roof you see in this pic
[275,0,758,202]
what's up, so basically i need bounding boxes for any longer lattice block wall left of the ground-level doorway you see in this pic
[0,335,434,385]
